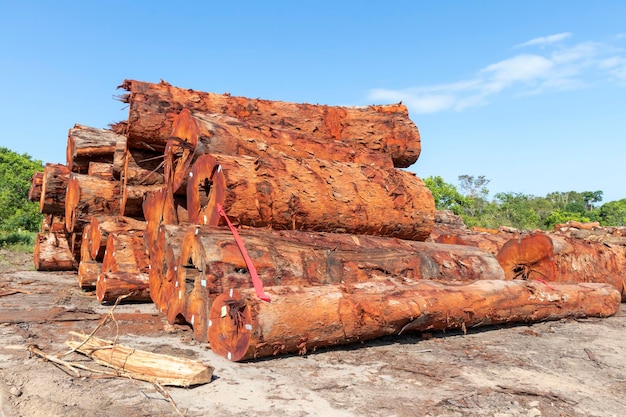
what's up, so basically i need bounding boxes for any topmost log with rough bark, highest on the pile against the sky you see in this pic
[120,80,421,167]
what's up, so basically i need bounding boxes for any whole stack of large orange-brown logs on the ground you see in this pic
[29,80,624,360]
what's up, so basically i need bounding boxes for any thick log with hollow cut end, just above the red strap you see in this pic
[187,154,435,240]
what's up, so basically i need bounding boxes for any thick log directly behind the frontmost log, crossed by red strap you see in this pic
[160,225,504,341]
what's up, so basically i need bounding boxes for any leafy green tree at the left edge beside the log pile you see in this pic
[0,148,43,231]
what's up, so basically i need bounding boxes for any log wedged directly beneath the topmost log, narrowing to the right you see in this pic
[165,108,393,190]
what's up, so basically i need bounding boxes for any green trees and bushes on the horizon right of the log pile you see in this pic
[424,175,626,230]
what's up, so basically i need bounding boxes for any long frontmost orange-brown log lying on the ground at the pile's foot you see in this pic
[209,279,620,361]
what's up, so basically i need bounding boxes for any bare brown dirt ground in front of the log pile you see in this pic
[0,250,626,417]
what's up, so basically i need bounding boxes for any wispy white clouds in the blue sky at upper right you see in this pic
[369,32,626,113]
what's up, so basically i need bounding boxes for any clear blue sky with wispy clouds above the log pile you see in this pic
[0,0,626,202]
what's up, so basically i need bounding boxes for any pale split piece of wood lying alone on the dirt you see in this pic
[65,332,213,387]
